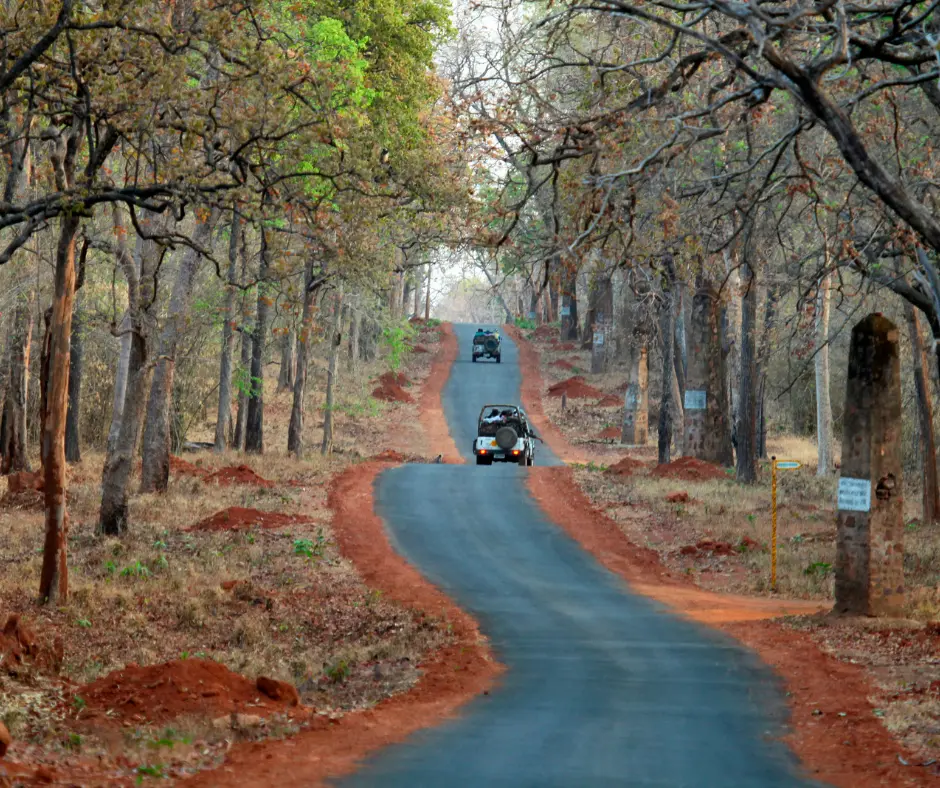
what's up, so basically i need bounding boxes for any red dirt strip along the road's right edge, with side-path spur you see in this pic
[519,418,937,788]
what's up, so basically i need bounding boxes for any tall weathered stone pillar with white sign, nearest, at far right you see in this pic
[834,313,904,616]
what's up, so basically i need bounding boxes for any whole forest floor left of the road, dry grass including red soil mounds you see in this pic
[0,320,449,785]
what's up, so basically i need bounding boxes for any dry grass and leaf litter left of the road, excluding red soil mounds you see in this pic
[0,328,448,780]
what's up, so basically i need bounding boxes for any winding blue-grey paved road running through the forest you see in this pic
[341,326,809,788]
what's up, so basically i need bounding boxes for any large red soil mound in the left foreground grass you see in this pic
[75,659,296,723]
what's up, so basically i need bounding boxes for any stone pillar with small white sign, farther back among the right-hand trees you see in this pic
[682,277,734,467]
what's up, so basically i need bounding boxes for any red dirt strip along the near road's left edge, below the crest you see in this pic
[183,462,503,787]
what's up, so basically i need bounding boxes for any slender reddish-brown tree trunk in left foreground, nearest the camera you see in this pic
[39,213,80,605]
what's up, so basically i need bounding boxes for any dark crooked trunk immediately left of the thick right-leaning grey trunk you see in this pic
[98,326,149,536]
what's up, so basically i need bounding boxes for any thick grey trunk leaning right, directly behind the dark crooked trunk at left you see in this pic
[140,212,218,492]
